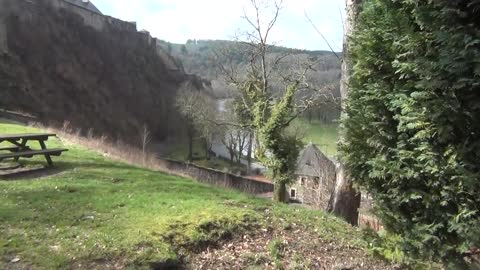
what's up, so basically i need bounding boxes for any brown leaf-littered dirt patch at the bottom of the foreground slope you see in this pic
[189,219,400,270]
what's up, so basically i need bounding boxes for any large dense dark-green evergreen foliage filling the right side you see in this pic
[340,0,480,263]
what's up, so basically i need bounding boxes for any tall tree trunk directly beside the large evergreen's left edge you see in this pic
[328,0,361,225]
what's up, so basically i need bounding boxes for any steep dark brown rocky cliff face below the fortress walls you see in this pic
[0,0,195,139]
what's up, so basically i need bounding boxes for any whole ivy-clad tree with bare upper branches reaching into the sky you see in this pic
[214,0,338,202]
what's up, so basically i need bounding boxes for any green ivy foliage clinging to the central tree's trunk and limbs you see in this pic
[234,75,303,202]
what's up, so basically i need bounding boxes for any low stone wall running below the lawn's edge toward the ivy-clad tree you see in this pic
[163,160,273,194]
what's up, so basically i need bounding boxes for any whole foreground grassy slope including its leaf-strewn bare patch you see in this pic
[0,120,392,269]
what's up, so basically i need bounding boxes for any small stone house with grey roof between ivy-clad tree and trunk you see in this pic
[287,144,336,209]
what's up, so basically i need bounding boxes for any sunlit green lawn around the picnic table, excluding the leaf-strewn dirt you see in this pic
[0,121,361,269]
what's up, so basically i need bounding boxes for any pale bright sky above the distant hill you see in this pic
[91,0,345,51]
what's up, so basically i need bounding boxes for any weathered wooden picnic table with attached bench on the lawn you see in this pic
[0,133,68,166]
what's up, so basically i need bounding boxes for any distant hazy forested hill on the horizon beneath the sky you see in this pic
[159,40,341,98]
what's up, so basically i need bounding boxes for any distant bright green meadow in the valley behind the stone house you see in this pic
[297,118,338,157]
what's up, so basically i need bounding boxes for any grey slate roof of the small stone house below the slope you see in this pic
[295,143,335,177]
